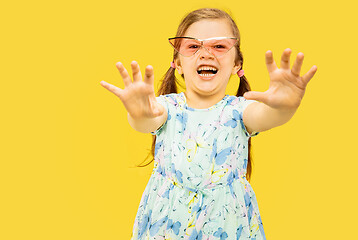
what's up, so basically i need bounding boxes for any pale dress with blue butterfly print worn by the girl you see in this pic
[131,92,266,240]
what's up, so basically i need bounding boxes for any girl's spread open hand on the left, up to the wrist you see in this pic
[101,61,165,119]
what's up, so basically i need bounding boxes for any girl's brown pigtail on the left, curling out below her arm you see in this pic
[137,67,178,167]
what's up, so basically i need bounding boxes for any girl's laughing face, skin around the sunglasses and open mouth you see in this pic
[176,19,241,97]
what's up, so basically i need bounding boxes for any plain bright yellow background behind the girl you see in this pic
[0,0,358,240]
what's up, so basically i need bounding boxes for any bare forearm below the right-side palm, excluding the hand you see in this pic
[244,102,297,132]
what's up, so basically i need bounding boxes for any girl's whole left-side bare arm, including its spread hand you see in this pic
[101,61,167,133]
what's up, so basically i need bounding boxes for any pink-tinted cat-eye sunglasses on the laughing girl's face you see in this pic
[169,38,236,57]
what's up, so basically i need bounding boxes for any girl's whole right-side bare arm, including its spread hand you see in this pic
[243,48,317,133]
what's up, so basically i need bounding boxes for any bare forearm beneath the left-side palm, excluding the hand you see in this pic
[128,111,168,133]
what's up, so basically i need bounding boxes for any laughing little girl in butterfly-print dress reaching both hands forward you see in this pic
[101,8,317,240]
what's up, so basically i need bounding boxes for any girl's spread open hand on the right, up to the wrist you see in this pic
[244,48,317,110]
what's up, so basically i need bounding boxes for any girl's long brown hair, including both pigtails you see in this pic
[137,8,252,181]
